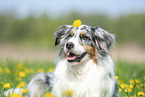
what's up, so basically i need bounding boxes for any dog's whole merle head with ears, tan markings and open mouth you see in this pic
[55,25,114,64]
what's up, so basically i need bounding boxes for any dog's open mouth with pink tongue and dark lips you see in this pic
[67,52,87,63]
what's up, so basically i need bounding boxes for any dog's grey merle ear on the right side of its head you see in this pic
[91,27,115,53]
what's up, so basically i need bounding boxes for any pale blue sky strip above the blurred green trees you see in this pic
[0,0,145,17]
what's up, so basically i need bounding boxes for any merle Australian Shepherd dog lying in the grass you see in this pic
[28,22,118,97]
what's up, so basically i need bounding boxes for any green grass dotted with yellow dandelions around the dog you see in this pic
[0,61,145,97]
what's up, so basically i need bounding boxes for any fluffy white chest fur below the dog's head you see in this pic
[53,56,115,97]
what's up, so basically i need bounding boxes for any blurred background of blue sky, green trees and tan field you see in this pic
[0,0,145,63]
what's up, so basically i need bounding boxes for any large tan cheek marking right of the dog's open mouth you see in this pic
[84,45,97,64]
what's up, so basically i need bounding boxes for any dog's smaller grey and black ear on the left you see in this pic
[54,25,72,46]
